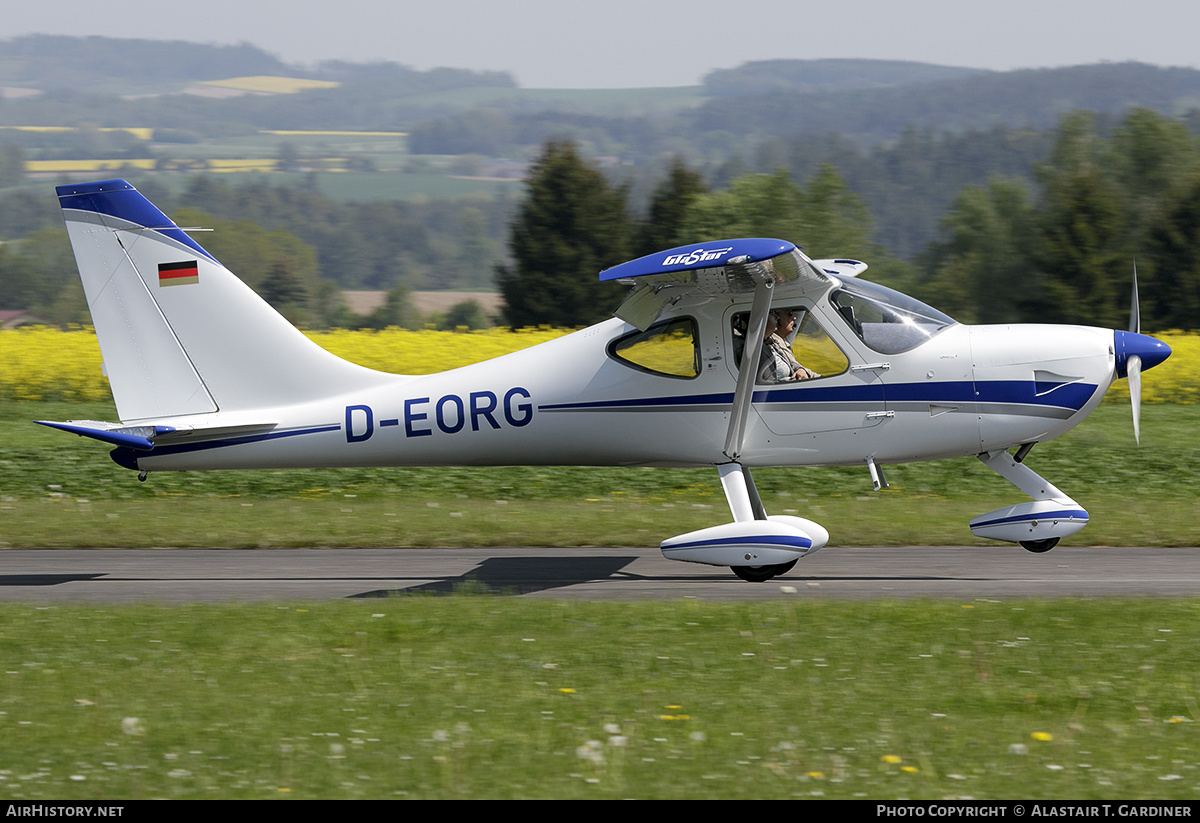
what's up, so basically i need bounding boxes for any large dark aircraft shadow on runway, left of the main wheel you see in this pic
[350,555,638,597]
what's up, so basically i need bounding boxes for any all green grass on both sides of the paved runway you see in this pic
[0,386,1200,800]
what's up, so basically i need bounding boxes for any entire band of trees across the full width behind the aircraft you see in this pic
[0,109,1200,330]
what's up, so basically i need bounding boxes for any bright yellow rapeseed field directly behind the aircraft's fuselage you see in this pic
[0,326,1200,404]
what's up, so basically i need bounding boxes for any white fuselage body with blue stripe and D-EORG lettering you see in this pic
[112,304,1114,470]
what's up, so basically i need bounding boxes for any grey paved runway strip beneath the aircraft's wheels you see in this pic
[0,546,1200,603]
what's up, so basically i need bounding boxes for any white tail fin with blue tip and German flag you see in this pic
[58,180,391,422]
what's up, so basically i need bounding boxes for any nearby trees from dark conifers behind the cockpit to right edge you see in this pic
[497,109,1200,330]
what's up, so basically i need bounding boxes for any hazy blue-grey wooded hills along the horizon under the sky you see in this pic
[0,35,1200,146]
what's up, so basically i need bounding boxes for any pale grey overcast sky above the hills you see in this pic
[7,0,1200,88]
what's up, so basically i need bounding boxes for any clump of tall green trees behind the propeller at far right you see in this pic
[918,109,1200,330]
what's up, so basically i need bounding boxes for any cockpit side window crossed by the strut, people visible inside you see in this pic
[732,306,850,384]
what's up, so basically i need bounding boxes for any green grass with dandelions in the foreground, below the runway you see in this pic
[0,594,1200,800]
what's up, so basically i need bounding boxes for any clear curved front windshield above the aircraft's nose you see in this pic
[829,280,954,354]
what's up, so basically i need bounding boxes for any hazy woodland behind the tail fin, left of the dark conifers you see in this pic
[0,172,512,328]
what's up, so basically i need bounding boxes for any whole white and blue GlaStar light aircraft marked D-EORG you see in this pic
[44,180,1170,581]
